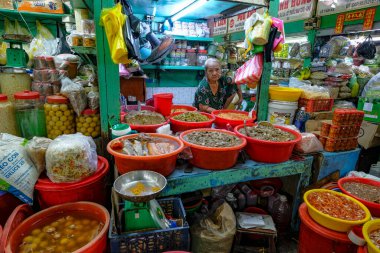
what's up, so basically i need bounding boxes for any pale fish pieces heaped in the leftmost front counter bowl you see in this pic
[111,134,178,156]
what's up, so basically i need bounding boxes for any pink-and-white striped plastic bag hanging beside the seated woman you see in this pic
[235,54,264,84]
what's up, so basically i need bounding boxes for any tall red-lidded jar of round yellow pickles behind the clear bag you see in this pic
[44,95,75,139]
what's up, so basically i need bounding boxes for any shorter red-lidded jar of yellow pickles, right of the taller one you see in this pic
[76,109,100,138]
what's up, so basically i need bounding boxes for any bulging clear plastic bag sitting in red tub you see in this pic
[46,133,98,183]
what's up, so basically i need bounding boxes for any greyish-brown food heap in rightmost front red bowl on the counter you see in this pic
[239,124,295,142]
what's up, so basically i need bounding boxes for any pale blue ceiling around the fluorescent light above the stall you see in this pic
[129,0,252,19]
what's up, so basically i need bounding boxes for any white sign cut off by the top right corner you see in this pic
[317,0,380,16]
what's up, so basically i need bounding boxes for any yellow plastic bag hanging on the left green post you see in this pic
[100,3,130,64]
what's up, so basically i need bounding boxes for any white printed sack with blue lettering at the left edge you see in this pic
[0,134,39,205]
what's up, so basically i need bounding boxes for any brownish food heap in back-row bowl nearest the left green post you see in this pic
[125,111,166,125]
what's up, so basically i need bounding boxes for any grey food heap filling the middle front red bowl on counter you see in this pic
[183,131,241,147]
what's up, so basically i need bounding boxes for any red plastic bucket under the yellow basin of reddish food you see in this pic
[298,203,358,253]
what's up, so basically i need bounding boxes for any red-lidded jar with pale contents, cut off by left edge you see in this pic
[0,94,17,135]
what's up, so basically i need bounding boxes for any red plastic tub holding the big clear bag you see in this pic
[35,156,109,209]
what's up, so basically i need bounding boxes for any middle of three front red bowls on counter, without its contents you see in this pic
[180,128,247,170]
